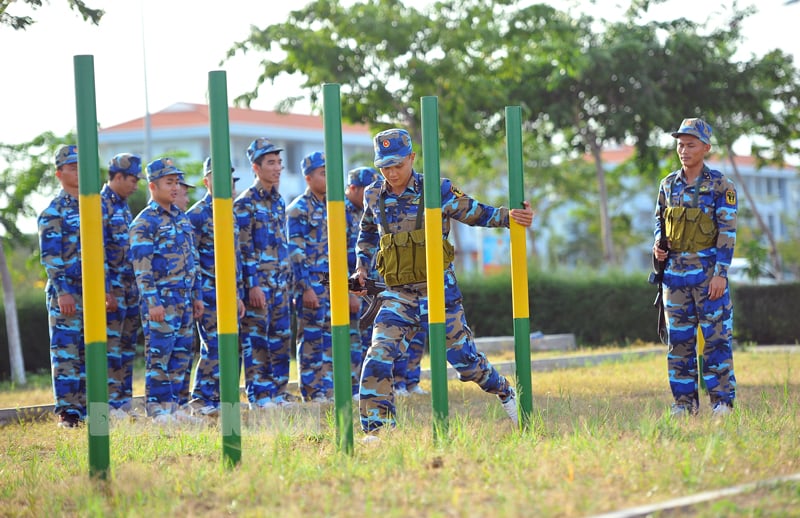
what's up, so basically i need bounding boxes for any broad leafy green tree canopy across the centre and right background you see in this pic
[228,0,800,264]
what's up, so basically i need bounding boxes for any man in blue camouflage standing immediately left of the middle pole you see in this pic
[286,151,333,402]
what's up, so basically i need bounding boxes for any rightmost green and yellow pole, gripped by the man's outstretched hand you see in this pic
[506,106,533,430]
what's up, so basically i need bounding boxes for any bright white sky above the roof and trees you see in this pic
[0,0,800,144]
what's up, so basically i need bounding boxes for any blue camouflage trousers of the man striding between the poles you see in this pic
[359,287,512,432]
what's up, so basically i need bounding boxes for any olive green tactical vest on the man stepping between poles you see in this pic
[375,188,455,286]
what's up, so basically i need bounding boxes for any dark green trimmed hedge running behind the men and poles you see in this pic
[0,271,800,379]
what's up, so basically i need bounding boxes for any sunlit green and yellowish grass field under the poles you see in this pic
[0,351,800,517]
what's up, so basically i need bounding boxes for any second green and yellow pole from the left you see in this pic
[208,70,242,467]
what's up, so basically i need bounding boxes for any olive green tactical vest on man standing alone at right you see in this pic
[664,168,719,252]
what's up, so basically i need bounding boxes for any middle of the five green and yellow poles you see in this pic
[322,83,353,454]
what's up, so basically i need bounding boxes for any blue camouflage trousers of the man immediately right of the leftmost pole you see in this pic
[106,276,142,409]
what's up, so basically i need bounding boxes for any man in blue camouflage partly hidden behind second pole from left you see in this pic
[187,157,244,415]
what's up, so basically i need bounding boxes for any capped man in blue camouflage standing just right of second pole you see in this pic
[233,138,296,408]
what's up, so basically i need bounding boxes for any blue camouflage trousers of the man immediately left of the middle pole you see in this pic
[296,273,333,401]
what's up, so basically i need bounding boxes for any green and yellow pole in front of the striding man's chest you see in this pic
[421,96,448,442]
